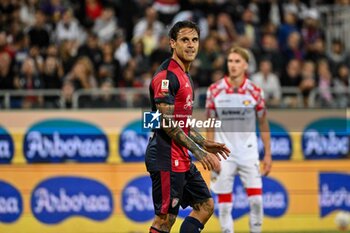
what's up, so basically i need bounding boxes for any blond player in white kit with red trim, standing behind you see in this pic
[206,47,272,233]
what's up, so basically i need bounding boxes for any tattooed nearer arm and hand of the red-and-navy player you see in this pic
[156,103,218,170]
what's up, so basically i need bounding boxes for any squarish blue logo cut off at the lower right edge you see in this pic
[319,172,350,217]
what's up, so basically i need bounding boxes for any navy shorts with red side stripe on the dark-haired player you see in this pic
[150,163,211,215]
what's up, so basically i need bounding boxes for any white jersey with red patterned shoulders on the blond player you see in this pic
[206,76,266,160]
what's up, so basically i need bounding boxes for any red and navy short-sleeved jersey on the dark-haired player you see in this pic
[146,59,194,172]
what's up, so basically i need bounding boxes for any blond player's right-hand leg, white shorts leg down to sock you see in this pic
[238,160,264,233]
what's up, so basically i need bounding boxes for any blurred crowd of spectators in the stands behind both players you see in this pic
[0,0,350,108]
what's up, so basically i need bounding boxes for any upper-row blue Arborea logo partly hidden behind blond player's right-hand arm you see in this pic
[257,121,293,160]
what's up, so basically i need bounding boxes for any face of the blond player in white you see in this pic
[227,53,248,78]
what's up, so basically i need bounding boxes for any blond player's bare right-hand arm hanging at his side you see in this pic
[259,114,272,176]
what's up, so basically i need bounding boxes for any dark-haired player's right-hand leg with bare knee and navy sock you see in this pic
[180,164,214,233]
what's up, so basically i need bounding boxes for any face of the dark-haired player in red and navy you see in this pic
[170,28,199,63]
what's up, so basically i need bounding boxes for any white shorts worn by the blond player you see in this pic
[210,159,262,194]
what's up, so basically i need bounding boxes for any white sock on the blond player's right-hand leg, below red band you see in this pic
[248,195,264,233]
